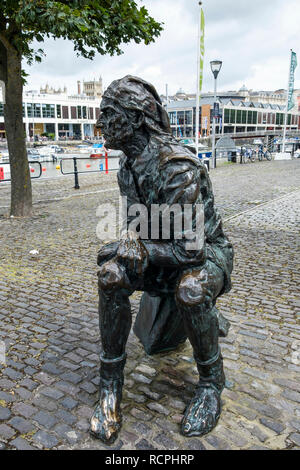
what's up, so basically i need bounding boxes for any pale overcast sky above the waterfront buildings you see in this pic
[25,0,300,95]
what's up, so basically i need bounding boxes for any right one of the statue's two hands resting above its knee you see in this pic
[117,232,149,275]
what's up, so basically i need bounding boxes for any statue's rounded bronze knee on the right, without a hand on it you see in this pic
[176,275,210,307]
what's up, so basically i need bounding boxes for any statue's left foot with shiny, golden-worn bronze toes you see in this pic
[90,380,122,444]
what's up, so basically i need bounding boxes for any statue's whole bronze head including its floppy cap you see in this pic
[96,75,170,149]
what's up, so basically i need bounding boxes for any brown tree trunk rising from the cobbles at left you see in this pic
[4,49,32,217]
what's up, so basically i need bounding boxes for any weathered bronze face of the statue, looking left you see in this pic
[97,97,133,150]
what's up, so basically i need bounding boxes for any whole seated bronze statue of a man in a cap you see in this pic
[91,76,233,444]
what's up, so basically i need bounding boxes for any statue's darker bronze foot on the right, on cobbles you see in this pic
[181,385,221,437]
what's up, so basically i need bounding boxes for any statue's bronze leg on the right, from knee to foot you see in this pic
[176,262,225,436]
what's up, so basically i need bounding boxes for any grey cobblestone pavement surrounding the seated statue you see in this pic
[0,161,300,450]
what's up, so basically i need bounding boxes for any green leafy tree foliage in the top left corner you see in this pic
[0,0,162,64]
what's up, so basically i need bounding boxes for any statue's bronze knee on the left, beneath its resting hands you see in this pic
[98,261,129,290]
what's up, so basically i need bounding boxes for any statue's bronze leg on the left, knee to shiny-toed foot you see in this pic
[90,260,134,444]
